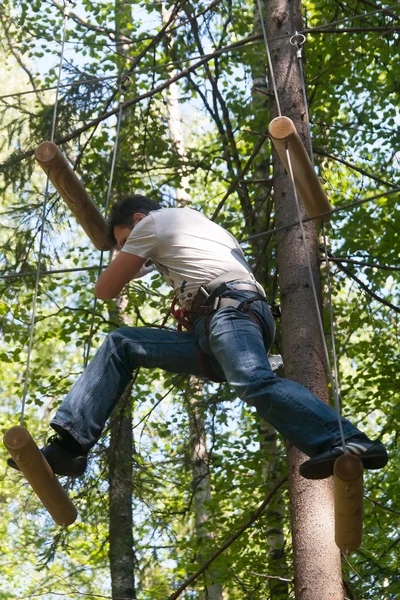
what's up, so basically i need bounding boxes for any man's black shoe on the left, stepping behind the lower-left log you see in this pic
[7,435,87,477]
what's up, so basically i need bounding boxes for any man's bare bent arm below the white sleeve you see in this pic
[94,252,146,300]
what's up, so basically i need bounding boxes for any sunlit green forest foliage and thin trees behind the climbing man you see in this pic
[0,0,400,600]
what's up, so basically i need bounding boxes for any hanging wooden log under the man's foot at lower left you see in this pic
[3,425,78,527]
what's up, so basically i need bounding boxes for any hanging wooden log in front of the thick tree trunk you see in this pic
[269,117,332,221]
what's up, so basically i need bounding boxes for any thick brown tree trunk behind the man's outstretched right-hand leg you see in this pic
[266,0,343,600]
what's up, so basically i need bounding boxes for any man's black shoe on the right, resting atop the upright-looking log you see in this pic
[300,438,388,479]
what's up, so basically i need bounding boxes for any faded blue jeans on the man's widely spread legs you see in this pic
[51,290,365,456]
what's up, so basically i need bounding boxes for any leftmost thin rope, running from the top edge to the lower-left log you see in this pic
[20,0,70,425]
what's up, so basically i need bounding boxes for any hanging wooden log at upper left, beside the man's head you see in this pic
[35,142,112,250]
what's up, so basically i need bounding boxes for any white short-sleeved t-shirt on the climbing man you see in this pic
[122,208,254,304]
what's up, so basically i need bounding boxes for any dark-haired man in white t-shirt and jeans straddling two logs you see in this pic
[9,195,388,479]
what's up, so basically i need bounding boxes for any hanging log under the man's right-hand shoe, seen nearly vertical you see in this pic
[333,453,363,552]
